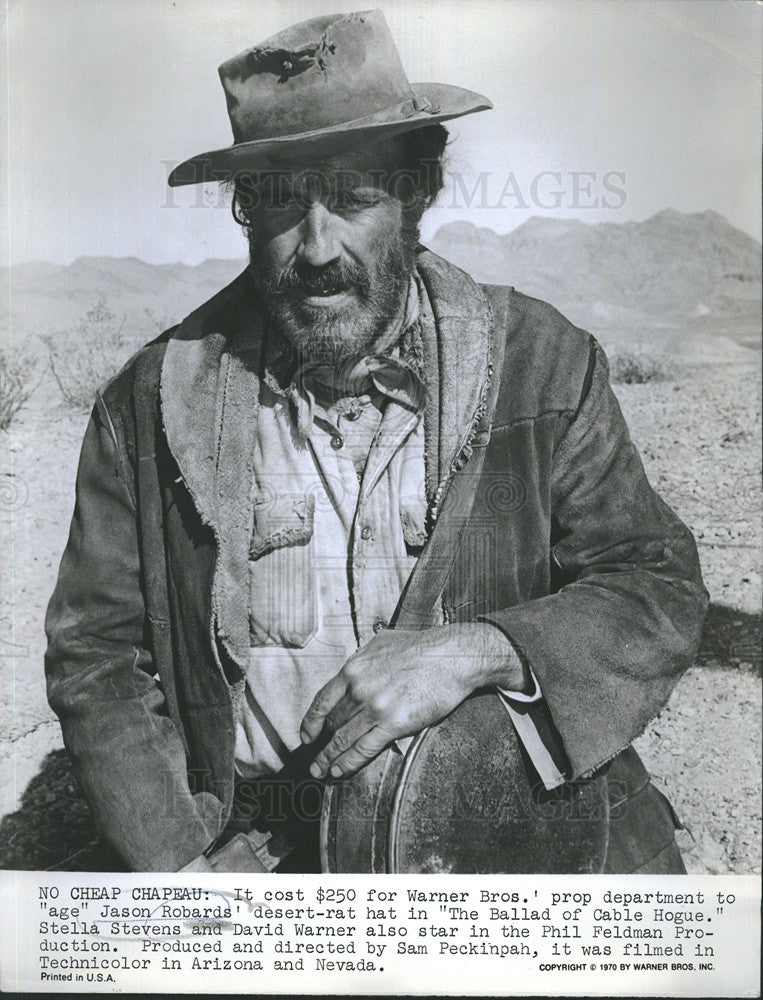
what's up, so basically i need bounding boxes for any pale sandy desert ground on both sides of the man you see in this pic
[0,278,761,873]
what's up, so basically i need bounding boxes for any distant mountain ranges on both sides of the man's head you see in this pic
[0,209,761,352]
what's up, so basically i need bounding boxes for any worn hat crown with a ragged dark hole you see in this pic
[219,10,413,143]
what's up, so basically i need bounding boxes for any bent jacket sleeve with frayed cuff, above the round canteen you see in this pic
[484,339,707,778]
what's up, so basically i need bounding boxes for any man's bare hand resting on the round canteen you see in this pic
[300,622,525,777]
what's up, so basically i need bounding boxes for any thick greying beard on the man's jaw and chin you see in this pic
[249,225,419,365]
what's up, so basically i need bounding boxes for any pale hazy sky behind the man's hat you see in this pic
[0,0,763,263]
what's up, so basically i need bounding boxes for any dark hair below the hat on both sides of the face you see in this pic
[231,123,448,229]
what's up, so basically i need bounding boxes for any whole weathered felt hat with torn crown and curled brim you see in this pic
[169,10,493,187]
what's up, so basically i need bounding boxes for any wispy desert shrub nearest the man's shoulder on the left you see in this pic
[43,299,136,410]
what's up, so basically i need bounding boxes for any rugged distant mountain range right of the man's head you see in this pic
[429,209,761,319]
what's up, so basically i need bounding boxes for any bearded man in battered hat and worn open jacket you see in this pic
[47,12,706,872]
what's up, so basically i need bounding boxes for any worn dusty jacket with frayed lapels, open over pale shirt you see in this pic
[46,250,707,871]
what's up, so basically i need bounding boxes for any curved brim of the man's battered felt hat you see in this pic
[167,83,493,187]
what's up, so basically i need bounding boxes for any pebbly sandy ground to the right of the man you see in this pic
[617,365,761,873]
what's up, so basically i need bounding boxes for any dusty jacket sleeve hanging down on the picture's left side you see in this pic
[45,398,222,871]
